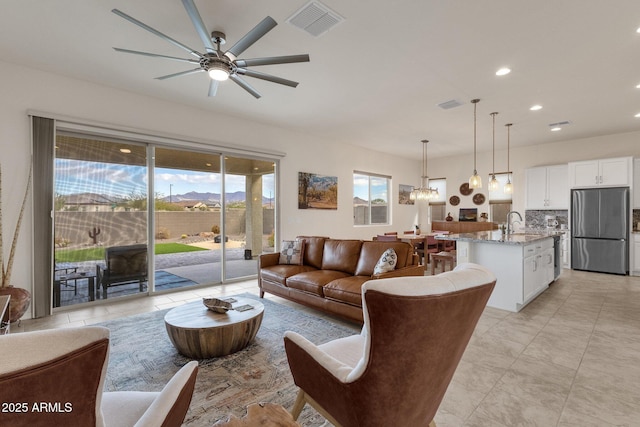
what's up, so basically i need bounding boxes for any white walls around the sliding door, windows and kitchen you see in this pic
[0,62,640,318]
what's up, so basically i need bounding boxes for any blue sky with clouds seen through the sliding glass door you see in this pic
[55,159,275,201]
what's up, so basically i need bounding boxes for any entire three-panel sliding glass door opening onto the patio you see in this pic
[52,131,276,309]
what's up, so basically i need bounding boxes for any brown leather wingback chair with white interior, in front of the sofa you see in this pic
[284,263,496,427]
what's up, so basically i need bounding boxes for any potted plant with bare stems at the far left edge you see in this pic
[0,167,31,323]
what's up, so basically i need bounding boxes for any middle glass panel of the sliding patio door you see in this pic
[153,147,224,291]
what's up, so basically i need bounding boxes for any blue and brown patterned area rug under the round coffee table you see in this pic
[100,294,360,427]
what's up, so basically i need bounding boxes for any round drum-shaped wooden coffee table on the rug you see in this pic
[164,297,264,359]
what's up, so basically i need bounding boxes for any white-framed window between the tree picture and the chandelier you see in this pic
[353,171,391,225]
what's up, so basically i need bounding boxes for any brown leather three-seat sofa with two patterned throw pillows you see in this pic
[258,236,424,323]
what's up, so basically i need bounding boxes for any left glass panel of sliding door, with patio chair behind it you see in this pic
[52,132,148,308]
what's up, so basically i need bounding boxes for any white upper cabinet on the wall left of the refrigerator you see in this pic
[525,165,569,210]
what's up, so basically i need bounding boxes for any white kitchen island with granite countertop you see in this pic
[436,230,554,312]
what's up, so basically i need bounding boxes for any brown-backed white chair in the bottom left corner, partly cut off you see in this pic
[0,326,198,427]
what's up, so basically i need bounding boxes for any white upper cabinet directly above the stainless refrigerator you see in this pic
[569,157,633,188]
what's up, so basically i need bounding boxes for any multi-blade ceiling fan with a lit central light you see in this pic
[112,0,309,98]
